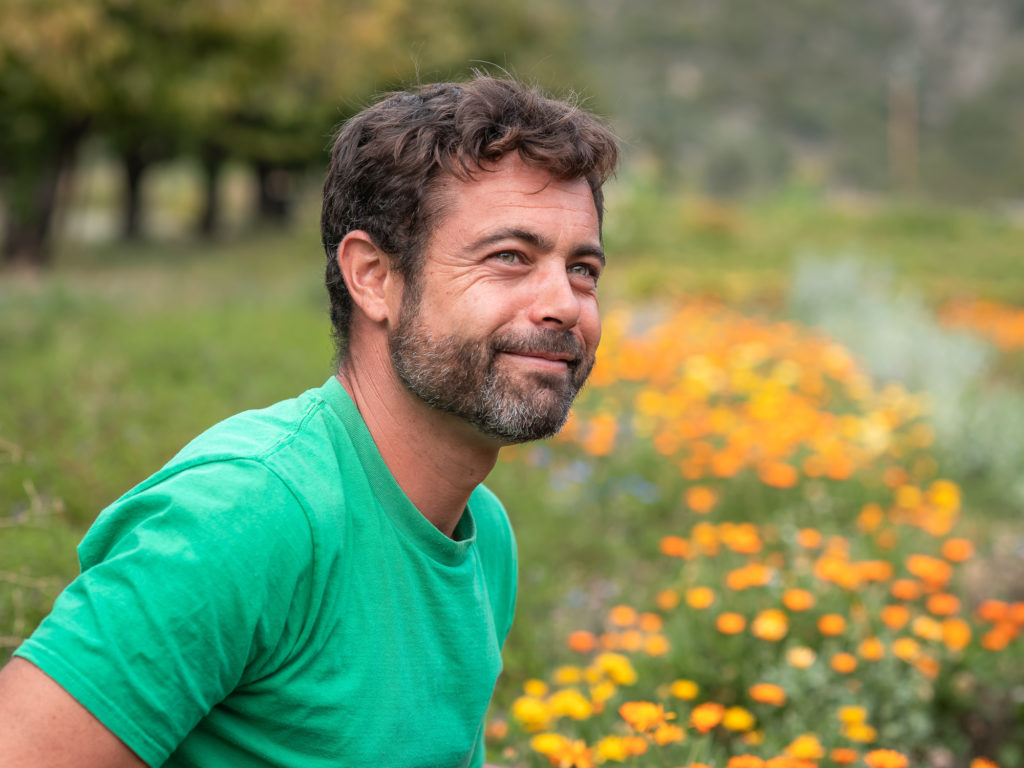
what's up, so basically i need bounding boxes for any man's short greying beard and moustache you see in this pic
[388,300,594,444]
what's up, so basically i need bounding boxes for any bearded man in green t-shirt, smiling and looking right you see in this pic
[0,77,615,767]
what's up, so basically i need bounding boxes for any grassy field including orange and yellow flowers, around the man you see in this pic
[0,184,1024,768]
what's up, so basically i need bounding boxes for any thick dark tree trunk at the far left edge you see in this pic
[2,120,87,268]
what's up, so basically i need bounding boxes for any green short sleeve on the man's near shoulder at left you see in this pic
[15,460,312,765]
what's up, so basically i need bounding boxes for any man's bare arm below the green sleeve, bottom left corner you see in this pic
[0,657,145,768]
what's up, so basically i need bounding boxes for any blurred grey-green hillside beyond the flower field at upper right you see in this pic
[571,0,1024,201]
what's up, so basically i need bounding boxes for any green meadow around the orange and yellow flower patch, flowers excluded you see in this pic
[0,185,1024,768]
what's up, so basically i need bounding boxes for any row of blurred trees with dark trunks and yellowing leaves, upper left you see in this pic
[0,0,570,263]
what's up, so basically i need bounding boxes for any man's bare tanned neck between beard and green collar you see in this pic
[338,355,499,537]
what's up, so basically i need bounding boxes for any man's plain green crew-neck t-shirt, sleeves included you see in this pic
[16,378,516,768]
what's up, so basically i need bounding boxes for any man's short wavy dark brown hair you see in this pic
[321,74,618,357]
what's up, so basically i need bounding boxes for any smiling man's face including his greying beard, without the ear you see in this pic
[389,155,604,443]
